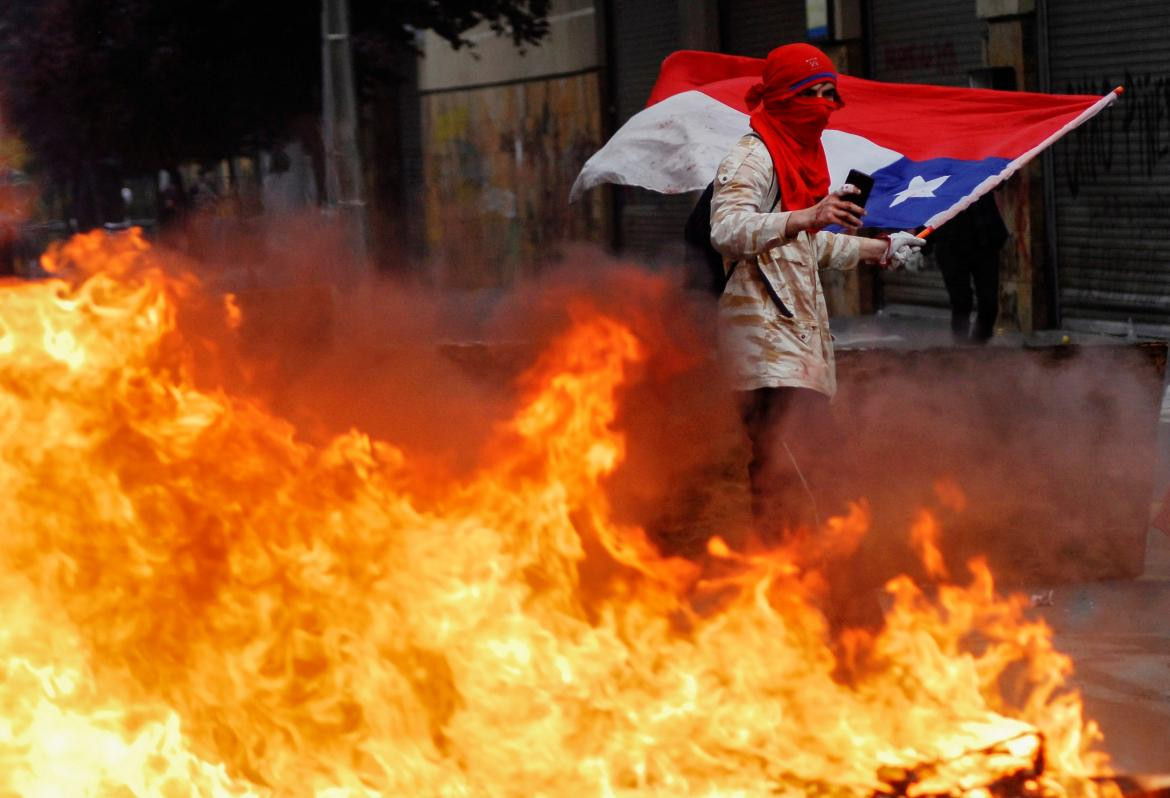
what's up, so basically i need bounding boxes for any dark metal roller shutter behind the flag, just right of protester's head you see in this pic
[870,0,987,308]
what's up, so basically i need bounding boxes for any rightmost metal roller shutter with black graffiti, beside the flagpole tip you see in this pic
[1047,0,1170,328]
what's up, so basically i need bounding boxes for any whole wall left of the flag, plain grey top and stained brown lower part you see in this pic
[419,0,610,288]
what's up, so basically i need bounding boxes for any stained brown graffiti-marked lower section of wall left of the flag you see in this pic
[422,73,604,288]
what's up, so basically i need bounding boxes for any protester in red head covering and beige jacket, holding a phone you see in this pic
[711,44,924,542]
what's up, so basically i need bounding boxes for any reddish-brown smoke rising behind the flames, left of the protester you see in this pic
[155,218,746,553]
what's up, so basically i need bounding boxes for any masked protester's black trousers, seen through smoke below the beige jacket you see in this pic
[741,387,842,543]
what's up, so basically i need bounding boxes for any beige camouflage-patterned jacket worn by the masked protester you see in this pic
[711,136,860,397]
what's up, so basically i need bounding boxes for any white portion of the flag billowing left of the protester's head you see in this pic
[569,91,749,201]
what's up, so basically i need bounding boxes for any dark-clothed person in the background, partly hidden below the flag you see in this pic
[927,193,1007,344]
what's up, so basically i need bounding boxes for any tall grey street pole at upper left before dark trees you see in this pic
[321,0,369,269]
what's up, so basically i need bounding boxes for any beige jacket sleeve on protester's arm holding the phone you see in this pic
[711,136,789,260]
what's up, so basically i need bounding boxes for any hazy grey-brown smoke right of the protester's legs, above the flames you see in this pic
[838,345,1162,586]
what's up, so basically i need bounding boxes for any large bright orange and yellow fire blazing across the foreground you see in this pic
[0,226,1109,798]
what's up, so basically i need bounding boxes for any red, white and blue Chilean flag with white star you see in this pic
[570,50,1120,229]
